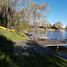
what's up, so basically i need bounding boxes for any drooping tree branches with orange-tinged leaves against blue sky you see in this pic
[31,2,48,27]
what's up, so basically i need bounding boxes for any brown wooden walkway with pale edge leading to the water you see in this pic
[29,39,67,46]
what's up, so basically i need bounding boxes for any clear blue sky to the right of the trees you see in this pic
[34,0,67,25]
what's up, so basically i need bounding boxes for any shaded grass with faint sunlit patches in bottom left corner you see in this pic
[0,52,19,67]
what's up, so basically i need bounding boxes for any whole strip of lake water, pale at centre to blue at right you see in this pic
[30,31,67,41]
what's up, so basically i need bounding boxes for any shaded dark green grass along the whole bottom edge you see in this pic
[0,51,67,67]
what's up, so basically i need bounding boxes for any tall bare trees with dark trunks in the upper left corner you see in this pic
[0,0,16,27]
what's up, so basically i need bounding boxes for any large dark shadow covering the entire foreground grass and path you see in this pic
[0,35,67,67]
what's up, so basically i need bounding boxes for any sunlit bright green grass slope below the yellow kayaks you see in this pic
[0,29,29,41]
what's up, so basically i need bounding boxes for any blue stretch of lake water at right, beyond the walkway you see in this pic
[48,31,67,40]
